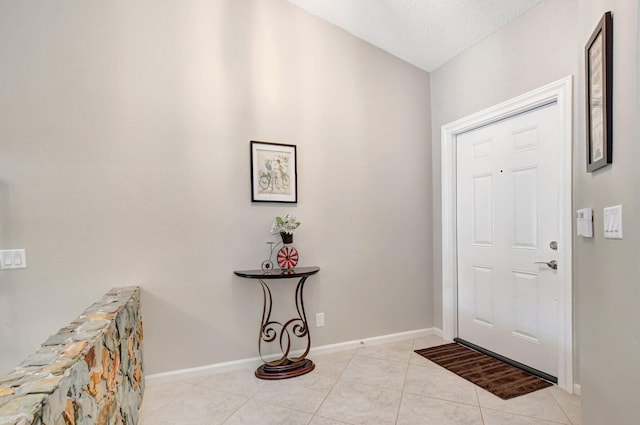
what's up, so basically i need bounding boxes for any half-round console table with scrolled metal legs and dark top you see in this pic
[234,267,320,379]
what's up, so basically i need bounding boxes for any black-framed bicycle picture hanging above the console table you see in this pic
[250,140,298,203]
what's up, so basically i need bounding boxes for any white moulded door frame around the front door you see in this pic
[440,76,573,393]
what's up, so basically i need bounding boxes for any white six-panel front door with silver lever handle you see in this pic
[456,102,568,376]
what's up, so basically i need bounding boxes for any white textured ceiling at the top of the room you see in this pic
[288,0,542,72]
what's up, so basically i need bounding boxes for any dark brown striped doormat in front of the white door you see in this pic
[415,343,552,400]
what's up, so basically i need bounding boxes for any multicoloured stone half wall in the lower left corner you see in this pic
[0,287,144,425]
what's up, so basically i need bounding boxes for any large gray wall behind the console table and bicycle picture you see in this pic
[0,0,433,373]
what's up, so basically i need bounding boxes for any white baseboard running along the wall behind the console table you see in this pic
[145,328,442,385]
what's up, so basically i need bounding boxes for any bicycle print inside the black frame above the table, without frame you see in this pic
[256,149,291,195]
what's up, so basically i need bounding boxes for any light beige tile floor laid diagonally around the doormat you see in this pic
[140,336,580,425]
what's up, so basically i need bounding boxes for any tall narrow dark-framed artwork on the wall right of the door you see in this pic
[584,12,613,173]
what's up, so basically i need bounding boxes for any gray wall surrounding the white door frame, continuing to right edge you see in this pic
[431,0,640,425]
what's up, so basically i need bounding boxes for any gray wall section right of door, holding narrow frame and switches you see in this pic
[574,0,640,425]
